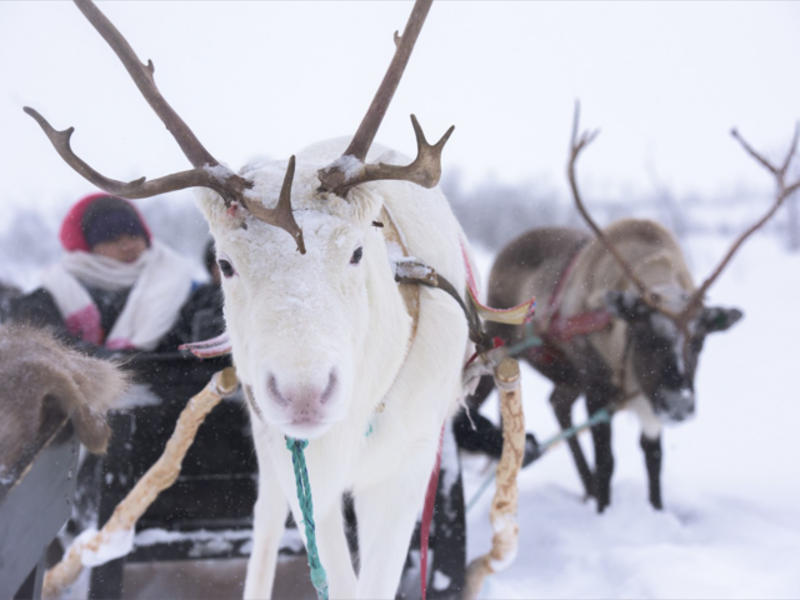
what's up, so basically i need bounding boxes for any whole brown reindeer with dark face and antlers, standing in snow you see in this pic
[471,110,800,512]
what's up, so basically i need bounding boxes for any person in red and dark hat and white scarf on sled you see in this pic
[10,194,193,355]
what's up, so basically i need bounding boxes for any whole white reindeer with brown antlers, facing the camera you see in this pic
[25,0,471,598]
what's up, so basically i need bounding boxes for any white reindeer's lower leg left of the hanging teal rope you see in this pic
[244,455,289,600]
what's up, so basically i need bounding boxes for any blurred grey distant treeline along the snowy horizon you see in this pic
[0,173,800,289]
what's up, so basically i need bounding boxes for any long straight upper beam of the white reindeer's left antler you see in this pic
[74,0,219,167]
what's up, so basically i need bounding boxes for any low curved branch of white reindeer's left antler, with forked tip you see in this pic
[23,106,221,200]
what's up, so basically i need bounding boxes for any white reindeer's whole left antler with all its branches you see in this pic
[24,0,305,254]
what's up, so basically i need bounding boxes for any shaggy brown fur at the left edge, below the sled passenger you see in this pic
[0,325,127,472]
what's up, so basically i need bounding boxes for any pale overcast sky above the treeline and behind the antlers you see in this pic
[0,0,800,220]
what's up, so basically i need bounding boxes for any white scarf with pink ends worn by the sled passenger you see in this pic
[42,240,192,350]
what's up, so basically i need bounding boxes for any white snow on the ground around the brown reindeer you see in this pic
[465,237,800,599]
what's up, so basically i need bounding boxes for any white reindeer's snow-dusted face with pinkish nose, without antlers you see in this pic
[194,162,387,439]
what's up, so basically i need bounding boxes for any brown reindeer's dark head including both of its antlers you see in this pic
[567,104,800,421]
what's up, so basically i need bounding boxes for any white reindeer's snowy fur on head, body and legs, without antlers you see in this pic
[198,140,469,598]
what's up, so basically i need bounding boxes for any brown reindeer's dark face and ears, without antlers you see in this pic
[606,291,743,422]
